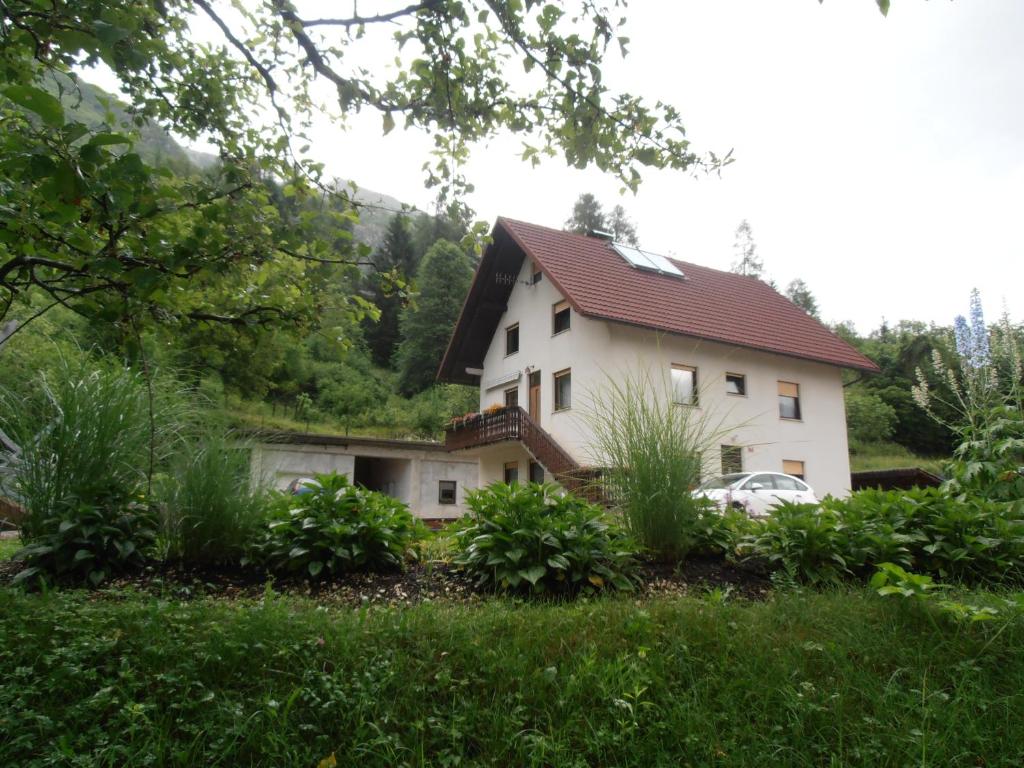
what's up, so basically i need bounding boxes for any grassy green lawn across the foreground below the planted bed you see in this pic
[0,591,1024,766]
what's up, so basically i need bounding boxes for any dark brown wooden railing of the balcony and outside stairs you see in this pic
[444,407,605,502]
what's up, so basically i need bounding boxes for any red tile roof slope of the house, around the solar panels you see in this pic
[495,217,879,371]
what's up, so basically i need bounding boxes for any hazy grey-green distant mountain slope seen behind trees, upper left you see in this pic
[49,78,415,250]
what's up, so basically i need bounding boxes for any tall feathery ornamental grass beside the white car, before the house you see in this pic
[584,372,728,560]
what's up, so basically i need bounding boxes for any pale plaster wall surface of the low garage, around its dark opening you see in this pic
[253,443,479,518]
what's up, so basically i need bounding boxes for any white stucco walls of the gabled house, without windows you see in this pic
[480,259,850,496]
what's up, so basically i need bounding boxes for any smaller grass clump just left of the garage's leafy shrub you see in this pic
[157,431,266,565]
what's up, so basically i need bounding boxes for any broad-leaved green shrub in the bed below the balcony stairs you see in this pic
[454,483,636,593]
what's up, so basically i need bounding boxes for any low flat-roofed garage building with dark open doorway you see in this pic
[253,433,479,519]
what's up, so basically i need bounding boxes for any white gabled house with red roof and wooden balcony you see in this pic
[438,218,878,495]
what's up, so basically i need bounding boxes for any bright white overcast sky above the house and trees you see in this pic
[94,0,1024,332]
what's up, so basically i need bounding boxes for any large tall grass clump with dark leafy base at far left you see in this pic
[0,360,167,584]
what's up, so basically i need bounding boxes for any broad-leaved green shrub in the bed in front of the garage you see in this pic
[249,474,424,579]
